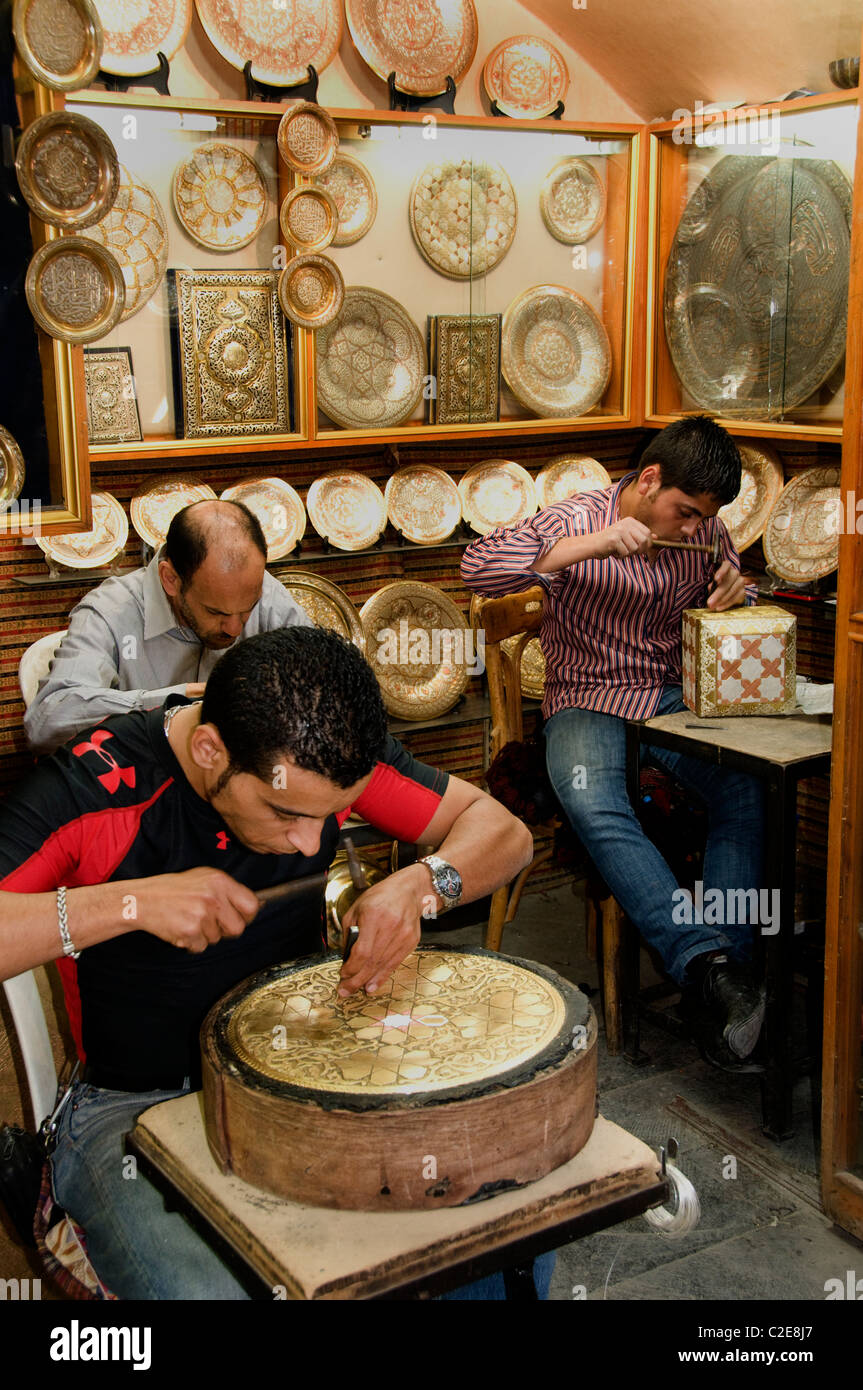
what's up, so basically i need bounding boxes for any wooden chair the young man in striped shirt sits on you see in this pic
[470,587,624,1055]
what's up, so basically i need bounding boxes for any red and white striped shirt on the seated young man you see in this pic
[461,473,756,719]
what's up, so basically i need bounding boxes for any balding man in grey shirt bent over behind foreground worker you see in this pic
[24,502,311,753]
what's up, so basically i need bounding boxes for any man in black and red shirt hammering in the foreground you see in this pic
[0,627,532,1298]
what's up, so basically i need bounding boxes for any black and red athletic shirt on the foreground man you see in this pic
[0,696,449,1081]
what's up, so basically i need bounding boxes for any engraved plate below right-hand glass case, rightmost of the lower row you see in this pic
[762,468,842,584]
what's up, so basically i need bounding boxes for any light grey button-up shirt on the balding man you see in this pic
[24,550,311,753]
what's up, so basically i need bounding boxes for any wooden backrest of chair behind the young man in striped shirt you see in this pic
[471,585,543,758]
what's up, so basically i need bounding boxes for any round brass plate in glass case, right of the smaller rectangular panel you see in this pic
[500,285,611,417]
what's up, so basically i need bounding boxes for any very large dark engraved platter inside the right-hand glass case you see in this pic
[664,154,850,418]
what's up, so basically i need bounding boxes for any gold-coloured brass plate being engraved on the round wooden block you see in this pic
[227,948,566,1097]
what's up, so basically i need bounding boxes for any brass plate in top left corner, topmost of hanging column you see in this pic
[13,0,103,92]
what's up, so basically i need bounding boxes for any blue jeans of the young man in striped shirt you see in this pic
[545,685,764,984]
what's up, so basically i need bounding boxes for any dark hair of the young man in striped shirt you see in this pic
[638,416,741,505]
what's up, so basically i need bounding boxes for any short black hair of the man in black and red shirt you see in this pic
[200,627,386,790]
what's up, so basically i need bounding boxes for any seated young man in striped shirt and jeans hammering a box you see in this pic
[461,416,764,1070]
